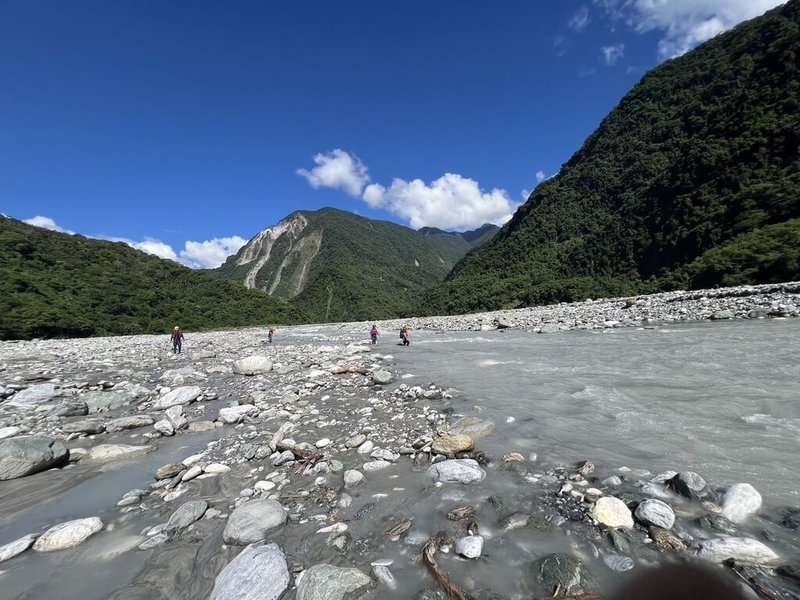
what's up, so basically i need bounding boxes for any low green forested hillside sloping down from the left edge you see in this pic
[0,217,303,339]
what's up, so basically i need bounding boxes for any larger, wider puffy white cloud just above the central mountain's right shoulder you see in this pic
[363,173,519,229]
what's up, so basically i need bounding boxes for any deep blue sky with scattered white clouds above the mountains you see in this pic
[0,0,783,267]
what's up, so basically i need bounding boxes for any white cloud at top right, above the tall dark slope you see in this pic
[594,0,786,60]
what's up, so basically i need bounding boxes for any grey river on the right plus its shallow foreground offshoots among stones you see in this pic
[346,320,800,598]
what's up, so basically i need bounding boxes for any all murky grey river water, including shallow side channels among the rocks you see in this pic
[0,320,800,600]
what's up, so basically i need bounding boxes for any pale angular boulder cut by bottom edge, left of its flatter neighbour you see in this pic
[211,544,290,600]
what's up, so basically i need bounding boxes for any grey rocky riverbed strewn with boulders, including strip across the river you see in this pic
[0,284,800,600]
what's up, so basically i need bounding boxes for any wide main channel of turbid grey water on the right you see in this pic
[395,320,800,505]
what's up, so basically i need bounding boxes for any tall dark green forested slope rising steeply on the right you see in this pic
[425,0,800,313]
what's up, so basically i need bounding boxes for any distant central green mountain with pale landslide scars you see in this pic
[213,208,497,321]
